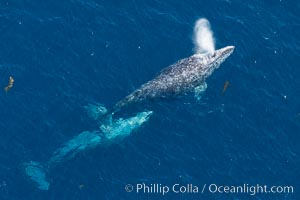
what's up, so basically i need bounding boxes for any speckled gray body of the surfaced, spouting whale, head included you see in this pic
[112,46,235,113]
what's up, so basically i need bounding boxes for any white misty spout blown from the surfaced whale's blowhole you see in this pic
[194,18,215,53]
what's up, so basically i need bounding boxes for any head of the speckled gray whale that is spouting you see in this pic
[195,46,235,77]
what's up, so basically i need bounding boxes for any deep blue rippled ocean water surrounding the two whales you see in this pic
[0,0,300,200]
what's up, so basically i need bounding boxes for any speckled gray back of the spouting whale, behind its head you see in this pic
[115,56,204,109]
